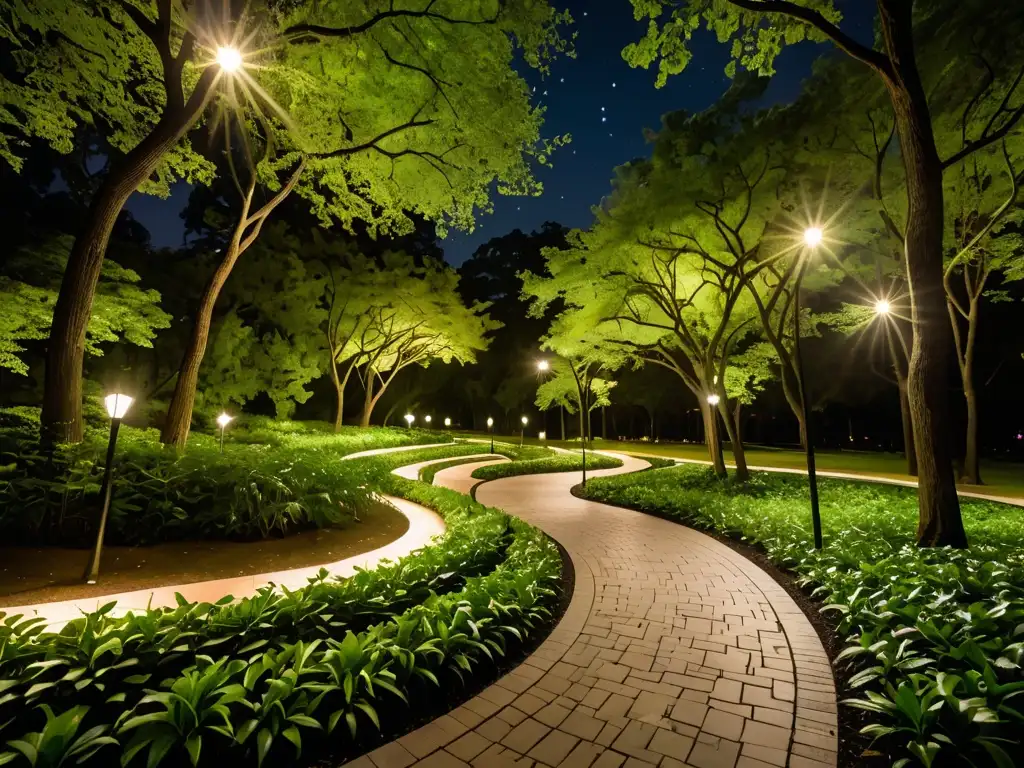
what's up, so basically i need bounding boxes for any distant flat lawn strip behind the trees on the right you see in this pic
[460,432,1024,498]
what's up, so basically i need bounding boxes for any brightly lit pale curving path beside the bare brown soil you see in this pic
[0,496,445,629]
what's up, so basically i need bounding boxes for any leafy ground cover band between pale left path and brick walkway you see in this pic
[0,445,561,766]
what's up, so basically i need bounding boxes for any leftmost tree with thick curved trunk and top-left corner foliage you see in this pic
[0,0,221,441]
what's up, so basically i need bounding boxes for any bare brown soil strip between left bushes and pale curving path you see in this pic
[0,503,409,605]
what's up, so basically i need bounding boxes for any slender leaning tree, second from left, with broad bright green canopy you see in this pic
[156,3,558,445]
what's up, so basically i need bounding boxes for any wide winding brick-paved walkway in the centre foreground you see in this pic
[356,456,837,768]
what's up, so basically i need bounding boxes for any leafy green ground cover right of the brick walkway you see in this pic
[582,465,1024,768]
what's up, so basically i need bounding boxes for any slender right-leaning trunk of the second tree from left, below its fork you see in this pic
[160,240,241,449]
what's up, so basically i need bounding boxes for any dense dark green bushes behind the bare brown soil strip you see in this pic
[0,409,448,545]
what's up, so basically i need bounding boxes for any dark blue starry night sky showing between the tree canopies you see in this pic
[121,0,874,265]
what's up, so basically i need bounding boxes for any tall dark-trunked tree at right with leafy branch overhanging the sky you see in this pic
[624,0,1024,547]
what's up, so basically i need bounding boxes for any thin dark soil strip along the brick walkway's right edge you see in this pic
[571,485,893,768]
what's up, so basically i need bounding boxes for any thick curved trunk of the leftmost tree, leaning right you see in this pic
[41,72,219,443]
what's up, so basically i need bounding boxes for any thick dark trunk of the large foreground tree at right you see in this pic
[878,0,967,547]
